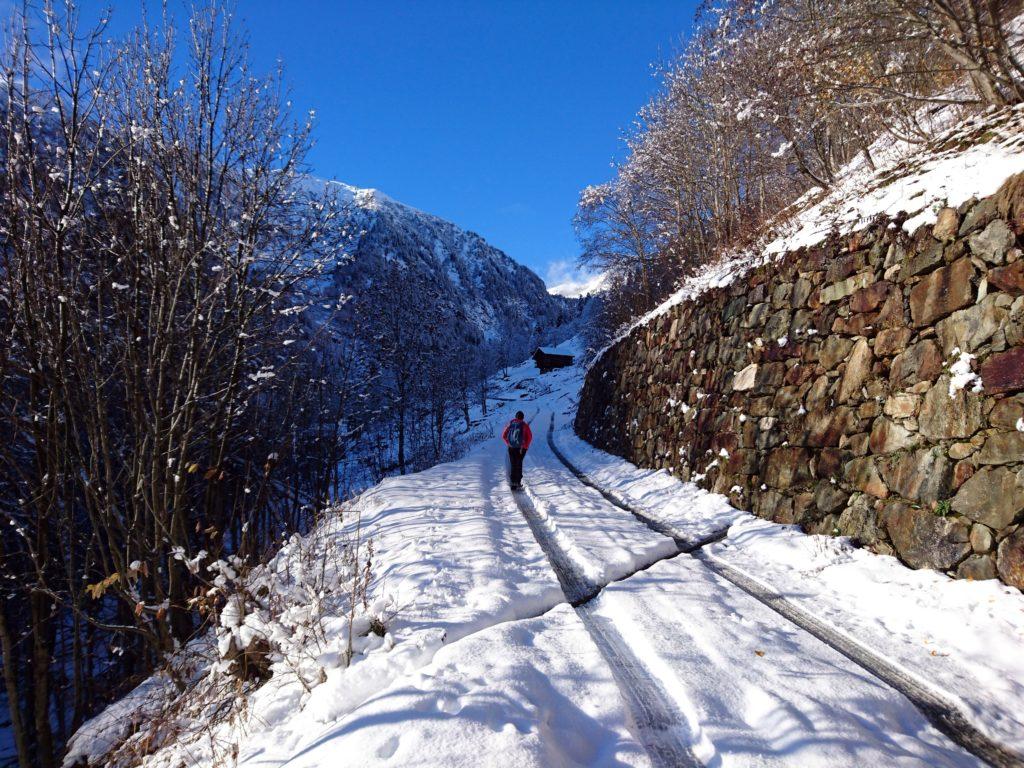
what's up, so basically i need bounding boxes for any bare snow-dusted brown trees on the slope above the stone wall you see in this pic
[574,0,1024,346]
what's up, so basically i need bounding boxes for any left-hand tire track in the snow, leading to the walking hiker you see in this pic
[505,475,701,768]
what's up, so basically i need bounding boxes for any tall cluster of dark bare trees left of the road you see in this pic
[0,4,348,766]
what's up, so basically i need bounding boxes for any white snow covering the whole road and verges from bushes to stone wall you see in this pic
[68,342,1024,768]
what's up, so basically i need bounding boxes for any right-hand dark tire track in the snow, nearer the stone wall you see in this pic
[548,414,1024,768]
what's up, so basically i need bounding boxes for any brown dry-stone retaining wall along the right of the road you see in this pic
[575,176,1024,588]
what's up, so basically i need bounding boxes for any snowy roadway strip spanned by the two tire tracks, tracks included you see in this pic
[516,405,999,766]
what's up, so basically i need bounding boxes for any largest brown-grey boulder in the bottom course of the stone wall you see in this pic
[884,501,971,570]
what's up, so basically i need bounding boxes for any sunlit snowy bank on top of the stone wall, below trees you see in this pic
[590,104,1024,366]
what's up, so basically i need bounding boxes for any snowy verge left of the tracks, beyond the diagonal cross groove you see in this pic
[65,452,562,768]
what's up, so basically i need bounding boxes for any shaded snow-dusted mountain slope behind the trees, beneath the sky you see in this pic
[328,182,574,352]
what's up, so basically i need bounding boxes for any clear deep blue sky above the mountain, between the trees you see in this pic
[82,0,695,288]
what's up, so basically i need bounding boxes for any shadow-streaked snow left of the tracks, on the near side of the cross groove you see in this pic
[289,605,648,768]
